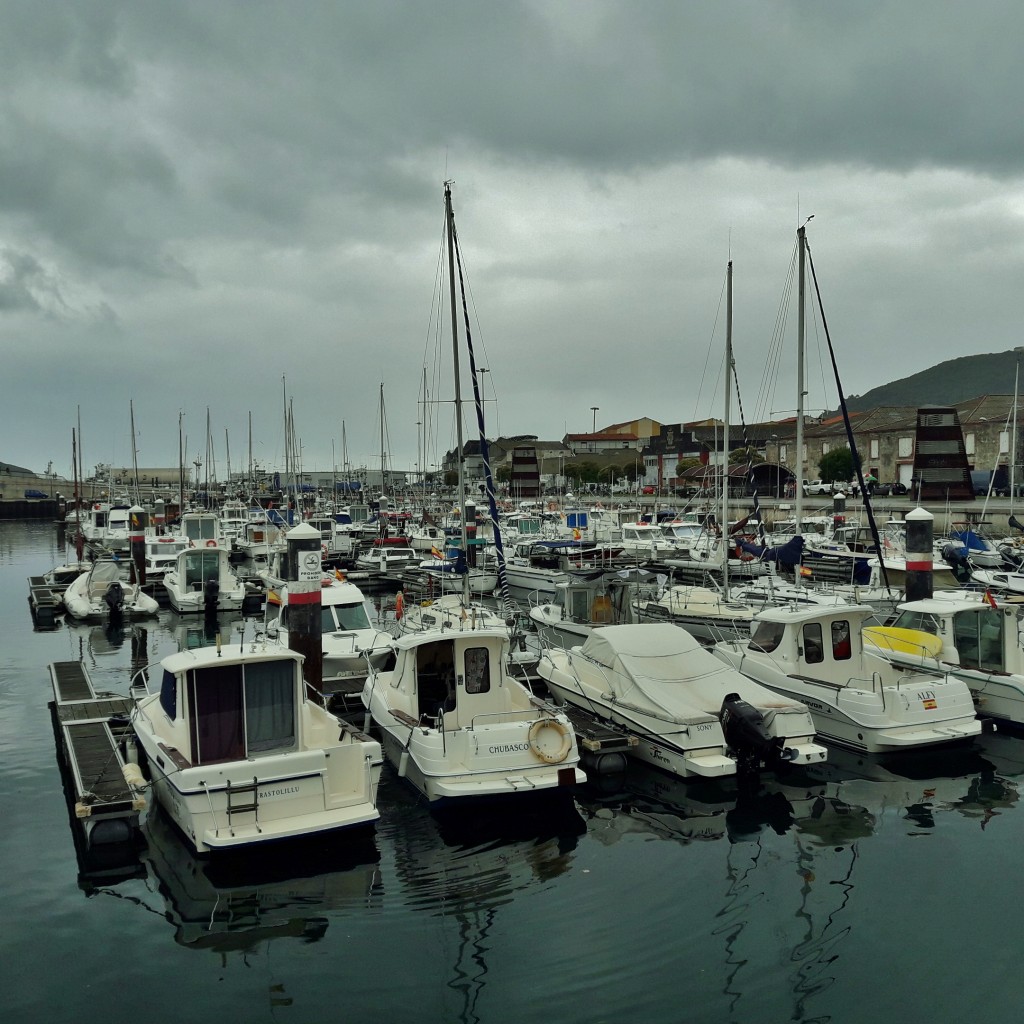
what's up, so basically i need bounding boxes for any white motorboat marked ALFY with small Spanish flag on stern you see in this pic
[713,605,981,754]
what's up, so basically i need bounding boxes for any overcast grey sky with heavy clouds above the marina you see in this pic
[0,0,1024,478]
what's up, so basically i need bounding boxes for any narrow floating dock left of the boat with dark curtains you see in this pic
[49,662,145,850]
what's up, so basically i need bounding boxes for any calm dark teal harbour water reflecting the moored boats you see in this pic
[0,522,1024,1024]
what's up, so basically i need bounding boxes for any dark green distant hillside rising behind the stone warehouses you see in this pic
[846,349,1024,413]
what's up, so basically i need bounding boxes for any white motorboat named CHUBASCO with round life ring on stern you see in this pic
[362,627,586,802]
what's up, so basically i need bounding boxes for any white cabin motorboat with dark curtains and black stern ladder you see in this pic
[132,641,382,853]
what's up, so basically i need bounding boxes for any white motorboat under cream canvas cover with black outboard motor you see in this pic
[538,623,825,778]
